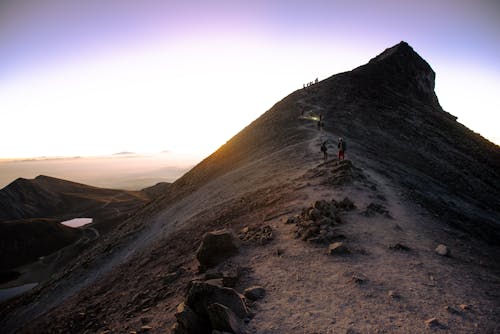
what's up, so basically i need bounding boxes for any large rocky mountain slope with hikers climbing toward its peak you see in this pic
[0,42,500,333]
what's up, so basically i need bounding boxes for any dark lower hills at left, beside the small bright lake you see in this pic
[0,175,154,272]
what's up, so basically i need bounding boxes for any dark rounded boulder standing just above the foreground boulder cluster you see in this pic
[196,230,238,270]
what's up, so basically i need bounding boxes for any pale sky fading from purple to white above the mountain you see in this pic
[0,0,500,159]
